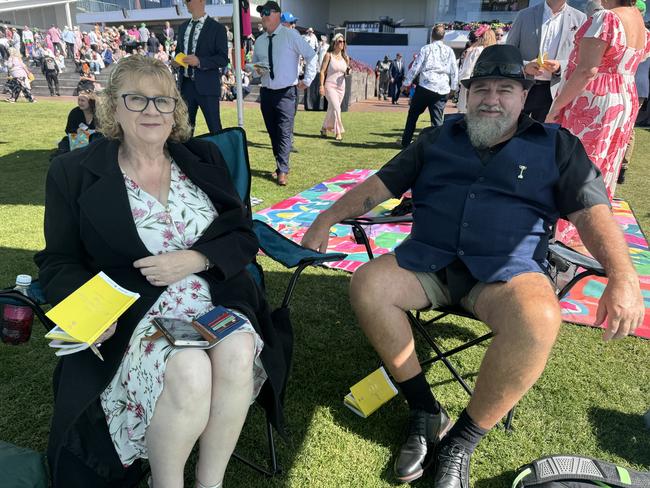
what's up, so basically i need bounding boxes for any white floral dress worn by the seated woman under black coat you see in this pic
[100,161,266,466]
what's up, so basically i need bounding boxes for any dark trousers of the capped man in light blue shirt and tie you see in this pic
[260,86,298,173]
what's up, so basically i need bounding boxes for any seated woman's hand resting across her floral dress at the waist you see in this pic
[133,250,206,286]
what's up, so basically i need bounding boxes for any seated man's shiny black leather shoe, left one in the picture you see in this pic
[394,408,451,483]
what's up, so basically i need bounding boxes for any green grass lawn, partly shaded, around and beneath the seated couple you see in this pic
[0,102,650,488]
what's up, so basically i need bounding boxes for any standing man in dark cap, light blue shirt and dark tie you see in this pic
[253,1,318,186]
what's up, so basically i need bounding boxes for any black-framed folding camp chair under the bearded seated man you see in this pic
[342,215,606,430]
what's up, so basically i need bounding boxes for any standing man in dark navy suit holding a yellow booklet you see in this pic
[176,0,228,133]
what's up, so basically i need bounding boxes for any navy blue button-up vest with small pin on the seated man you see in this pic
[395,117,559,283]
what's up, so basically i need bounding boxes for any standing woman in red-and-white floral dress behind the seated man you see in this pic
[546,0,650,244]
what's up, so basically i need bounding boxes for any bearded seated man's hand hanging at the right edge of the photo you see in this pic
[594,276,645,341]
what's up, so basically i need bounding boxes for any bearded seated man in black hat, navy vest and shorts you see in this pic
[302,45,644,488]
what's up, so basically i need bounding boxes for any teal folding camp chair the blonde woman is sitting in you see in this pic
[0,127,346,476]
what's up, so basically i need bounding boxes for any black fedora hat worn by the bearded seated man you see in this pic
[461,44,535,90]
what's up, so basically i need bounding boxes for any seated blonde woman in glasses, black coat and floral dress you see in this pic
[35,55,290,488]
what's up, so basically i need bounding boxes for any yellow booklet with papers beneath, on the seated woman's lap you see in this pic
[45,271,140,356]
